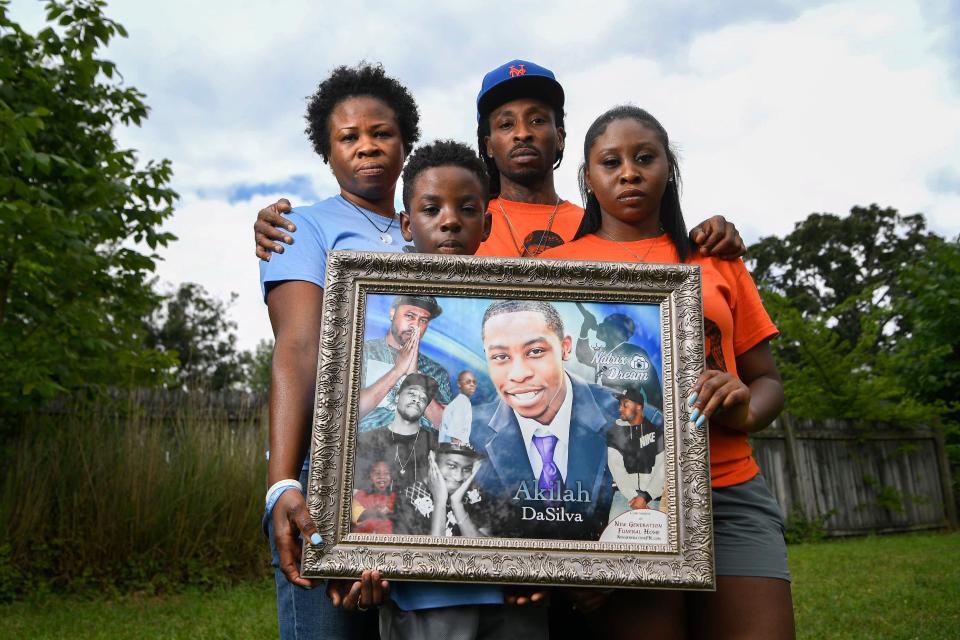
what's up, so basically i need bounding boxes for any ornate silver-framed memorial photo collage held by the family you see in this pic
[302,251,715,589]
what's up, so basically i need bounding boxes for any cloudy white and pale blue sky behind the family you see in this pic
[11,0,960,348]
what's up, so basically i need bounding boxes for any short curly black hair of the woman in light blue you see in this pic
[306,62,420,163]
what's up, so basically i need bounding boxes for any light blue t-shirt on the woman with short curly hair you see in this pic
[260,195,413,301]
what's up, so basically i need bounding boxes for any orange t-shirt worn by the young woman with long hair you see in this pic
[541,235,779,487]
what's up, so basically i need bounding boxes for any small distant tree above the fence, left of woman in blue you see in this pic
[146,282,254,391]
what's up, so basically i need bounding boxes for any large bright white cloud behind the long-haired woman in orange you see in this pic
[560,1,960,240]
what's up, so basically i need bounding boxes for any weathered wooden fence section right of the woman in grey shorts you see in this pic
[752,415,957,536]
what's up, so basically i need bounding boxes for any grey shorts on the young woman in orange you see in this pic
[713,474,790,582]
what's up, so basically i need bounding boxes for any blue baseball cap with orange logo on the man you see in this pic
[477,60,563,122]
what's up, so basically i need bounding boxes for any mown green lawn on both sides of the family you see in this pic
[0,533,960,640]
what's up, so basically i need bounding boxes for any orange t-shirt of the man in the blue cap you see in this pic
[477,198,583,258]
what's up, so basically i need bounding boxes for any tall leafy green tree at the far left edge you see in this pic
[0,0,176,414]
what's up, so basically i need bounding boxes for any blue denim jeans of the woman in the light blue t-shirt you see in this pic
[264,470,378,640]
